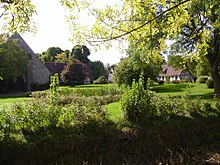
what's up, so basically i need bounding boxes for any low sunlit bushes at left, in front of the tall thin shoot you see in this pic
[0,99,108,141]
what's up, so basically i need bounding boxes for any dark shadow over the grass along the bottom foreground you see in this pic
[0,116,220,165]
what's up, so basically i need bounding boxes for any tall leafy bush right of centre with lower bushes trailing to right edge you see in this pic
[121,79,219,124]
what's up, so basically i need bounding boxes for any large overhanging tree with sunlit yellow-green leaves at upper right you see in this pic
[61,0,220,96]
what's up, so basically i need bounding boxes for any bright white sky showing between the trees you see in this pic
[21,0,125,64]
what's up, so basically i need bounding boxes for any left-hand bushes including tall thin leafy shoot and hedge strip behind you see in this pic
[0,76,121,141]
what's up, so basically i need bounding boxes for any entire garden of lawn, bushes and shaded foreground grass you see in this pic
[0,75,220,164]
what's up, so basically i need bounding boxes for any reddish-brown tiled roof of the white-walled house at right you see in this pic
[159,65,182,76]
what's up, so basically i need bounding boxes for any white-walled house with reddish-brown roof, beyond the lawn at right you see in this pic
[158,65,193,82]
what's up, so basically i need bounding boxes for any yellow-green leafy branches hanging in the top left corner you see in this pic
[0,0,36,43]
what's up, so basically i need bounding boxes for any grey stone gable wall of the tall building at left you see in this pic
[10,34,51,91]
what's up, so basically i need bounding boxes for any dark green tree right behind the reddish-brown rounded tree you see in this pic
[89,61,107,81]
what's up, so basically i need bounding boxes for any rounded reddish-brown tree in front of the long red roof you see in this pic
[61,59,85,85]
